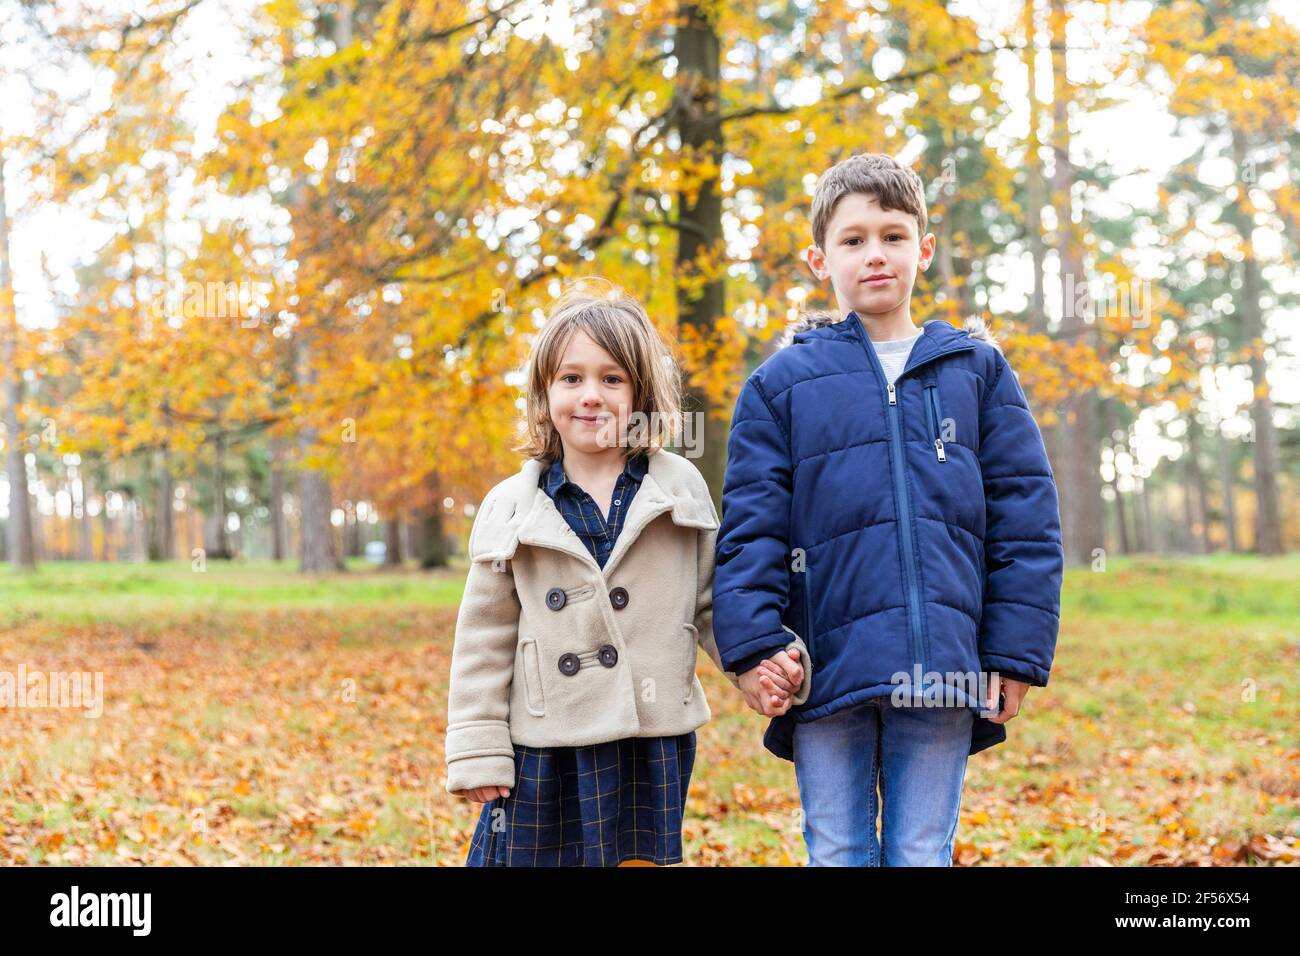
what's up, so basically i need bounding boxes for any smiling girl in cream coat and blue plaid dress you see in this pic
[446,277,811,866]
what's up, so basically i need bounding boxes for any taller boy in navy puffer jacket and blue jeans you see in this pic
[714,153,1063,866]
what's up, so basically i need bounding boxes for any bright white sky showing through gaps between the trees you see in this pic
[0,0,1300,502]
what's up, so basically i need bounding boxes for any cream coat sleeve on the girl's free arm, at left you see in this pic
[446,501,520,792]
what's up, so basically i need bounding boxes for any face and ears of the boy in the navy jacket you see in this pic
[807,193,935,323]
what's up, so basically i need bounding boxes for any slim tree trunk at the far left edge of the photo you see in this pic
[0,148,36,571]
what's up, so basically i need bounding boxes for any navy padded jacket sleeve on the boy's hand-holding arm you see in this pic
[714,376,813,704]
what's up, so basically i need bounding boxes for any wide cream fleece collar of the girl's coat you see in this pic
[469,450,718,575]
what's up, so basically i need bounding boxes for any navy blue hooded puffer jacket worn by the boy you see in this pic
[714,312,1063,760]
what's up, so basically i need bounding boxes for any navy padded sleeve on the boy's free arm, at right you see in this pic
[979,352,1065,687]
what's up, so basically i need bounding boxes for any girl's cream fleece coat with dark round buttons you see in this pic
[446,451,813,792]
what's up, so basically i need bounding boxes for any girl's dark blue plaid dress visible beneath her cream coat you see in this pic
[465,454,696,866]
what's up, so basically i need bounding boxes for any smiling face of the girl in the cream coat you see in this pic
[546,329,633,455]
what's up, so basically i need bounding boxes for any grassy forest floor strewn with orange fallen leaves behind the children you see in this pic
[0,555,1300,866]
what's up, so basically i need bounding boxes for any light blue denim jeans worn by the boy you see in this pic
[794,697,975,866]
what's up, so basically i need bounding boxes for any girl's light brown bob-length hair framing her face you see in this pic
[515,276,681,462]
